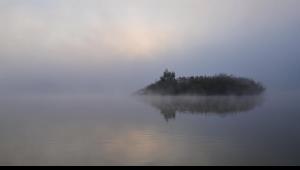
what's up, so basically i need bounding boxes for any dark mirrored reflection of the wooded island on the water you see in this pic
[142,96,263,121]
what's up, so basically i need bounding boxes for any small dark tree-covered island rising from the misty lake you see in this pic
[138,70,265,96]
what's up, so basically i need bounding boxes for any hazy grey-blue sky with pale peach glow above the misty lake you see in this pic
[0,0,300,94]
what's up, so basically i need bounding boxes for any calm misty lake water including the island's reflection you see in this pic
[0,93,300,165]
